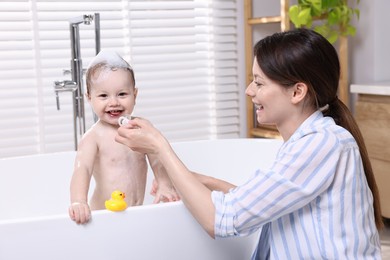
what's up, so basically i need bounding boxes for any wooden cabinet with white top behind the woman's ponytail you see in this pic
[351,82,390,218]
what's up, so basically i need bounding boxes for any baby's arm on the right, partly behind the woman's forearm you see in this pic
[148,155,180,203]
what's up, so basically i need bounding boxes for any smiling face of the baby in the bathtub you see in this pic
[88,69,137,125]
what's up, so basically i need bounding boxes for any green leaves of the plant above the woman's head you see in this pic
[289,0,360,43]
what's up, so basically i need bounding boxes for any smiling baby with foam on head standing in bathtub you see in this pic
[69,51,179,224]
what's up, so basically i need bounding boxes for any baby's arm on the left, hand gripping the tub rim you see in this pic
[69,133,97,224]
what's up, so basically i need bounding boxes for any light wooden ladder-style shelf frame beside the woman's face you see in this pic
[244,0,290,138]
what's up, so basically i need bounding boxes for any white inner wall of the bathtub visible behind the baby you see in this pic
[0,139,280,221]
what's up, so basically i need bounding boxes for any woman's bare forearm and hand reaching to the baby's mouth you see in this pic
[115,118,219,237]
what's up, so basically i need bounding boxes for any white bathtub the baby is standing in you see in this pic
[0,139,281,260]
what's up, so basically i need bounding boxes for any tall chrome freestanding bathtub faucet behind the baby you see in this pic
[54,13,100,150]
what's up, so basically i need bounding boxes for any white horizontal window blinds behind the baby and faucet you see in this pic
[0,0,240,157]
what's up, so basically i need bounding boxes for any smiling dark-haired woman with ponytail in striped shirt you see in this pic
[116,29,383,259]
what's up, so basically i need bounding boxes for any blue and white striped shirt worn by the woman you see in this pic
[212,111,381,259]
